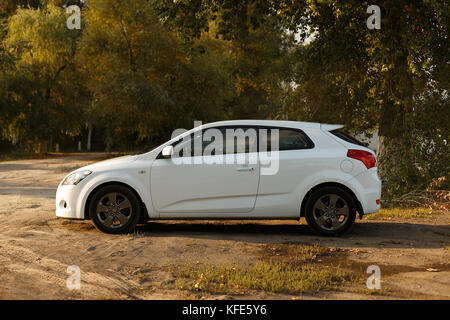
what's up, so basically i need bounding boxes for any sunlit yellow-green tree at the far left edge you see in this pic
[4,4,80,152]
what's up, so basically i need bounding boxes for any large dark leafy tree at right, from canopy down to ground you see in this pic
[286,1,450,195]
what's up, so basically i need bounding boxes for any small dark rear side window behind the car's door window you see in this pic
[260,128,314,151]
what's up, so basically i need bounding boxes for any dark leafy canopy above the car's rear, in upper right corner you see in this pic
[284,1,449,137]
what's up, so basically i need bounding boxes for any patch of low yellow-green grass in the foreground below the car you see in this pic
[173,245,354,294]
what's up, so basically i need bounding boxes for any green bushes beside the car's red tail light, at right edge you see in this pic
[380,91,450,199]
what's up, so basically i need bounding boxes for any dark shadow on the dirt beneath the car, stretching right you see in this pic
[132,221,450,248]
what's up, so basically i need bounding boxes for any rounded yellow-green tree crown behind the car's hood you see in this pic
[77,0,176,145]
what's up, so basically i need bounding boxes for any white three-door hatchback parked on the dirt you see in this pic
[56,120,381,235]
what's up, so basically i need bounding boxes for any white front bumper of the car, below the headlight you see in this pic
[56,185,84,219]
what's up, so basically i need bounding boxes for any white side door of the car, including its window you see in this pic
[150,127,259,217]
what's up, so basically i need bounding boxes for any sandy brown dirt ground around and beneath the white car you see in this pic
[0,156,450,299]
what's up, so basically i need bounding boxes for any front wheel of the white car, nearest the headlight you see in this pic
[89,185,141,234]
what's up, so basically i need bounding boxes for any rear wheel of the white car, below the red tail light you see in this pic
[305,187,356,236]
